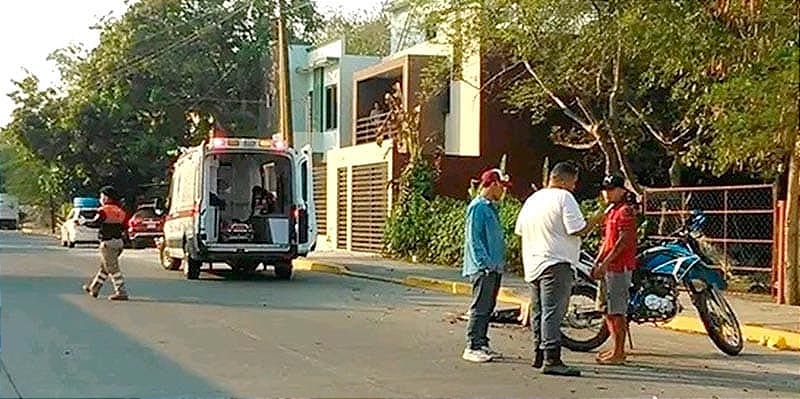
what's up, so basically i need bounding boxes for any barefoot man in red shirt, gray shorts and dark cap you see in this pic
[593,175,636,364]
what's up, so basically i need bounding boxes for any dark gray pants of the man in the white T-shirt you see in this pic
[531,263,575,350]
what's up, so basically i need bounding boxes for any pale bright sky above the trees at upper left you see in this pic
[0,0,378,126]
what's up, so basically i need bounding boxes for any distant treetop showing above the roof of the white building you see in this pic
[313,1,390,56]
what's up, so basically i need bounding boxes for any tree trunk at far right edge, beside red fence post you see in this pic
[784,136,800,305]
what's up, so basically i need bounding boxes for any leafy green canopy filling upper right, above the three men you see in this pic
[412,0,798,185]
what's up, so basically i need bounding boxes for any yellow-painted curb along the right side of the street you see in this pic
[294,259,800,351]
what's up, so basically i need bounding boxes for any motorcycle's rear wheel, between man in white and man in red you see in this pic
[561,285,610,352]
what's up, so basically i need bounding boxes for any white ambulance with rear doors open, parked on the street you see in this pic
[158,137,317,280]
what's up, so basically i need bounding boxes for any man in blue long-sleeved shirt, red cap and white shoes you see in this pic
[462,169,511,363]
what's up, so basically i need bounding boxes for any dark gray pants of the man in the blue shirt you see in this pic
[467,272,503,349]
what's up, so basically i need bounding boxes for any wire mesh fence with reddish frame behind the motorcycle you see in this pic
[643,185,775,272]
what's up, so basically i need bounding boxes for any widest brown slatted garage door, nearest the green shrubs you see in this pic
[351,162,389,252]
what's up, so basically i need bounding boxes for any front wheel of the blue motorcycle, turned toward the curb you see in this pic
[695,286,744,356]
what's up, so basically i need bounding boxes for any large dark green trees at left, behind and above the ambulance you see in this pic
[0,0,318,211]
